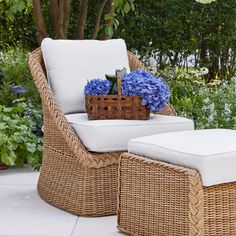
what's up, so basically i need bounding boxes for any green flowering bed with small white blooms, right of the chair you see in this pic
[158,68,236,129]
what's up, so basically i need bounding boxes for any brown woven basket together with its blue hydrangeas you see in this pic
[84,68,170,120]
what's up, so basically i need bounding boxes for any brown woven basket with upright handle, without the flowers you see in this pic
[85,71,150,120]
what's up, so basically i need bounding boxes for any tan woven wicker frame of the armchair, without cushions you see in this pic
[29,48,175,216]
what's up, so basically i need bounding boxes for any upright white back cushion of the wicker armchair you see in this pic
[41,38,130,114]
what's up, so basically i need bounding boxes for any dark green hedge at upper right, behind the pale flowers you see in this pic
[115,0,236,81]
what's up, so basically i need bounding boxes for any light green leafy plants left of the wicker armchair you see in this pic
[0,48,42,169]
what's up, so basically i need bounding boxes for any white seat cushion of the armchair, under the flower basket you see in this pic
[66,114,194,152]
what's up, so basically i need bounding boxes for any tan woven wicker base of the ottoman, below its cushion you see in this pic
[118,153,236,236]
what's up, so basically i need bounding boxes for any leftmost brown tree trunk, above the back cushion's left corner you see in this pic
[33,0,47,44]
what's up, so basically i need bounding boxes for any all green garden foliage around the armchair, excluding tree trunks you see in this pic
[0,0,236,169]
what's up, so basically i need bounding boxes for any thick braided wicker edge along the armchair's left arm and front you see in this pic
[29,48,118,168]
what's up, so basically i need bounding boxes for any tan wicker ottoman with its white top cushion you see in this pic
[118,129,236,236]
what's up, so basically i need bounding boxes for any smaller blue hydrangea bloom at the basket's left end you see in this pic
[84,79,111,96]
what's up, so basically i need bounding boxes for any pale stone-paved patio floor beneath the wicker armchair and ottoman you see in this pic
[0,167,124,236]
